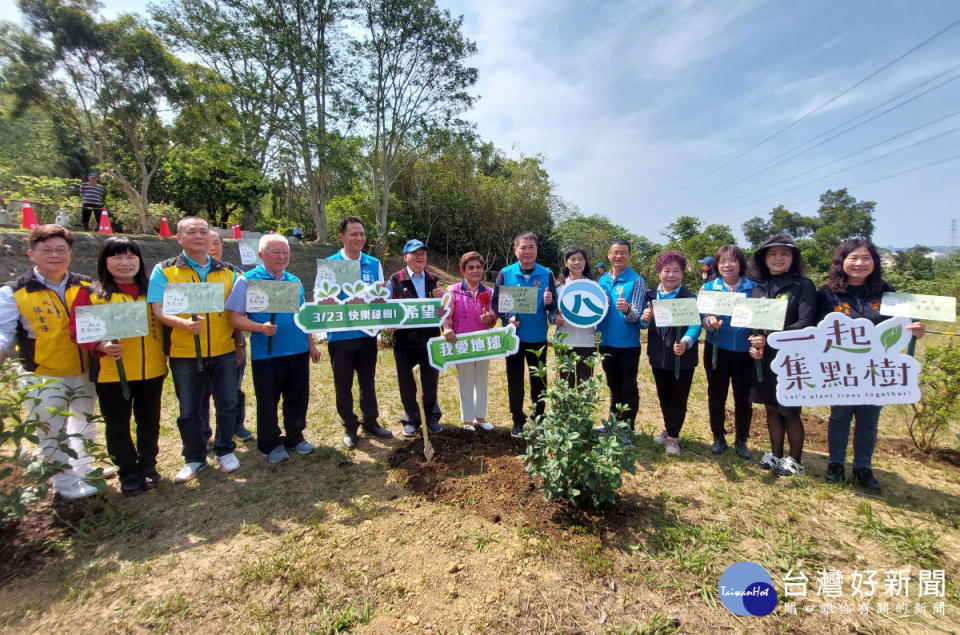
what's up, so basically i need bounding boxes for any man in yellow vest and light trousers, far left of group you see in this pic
[0,225,97,499]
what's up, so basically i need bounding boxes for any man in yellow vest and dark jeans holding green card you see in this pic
[147,217,240,483]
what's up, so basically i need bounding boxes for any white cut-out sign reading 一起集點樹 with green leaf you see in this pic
[767,312,920,406]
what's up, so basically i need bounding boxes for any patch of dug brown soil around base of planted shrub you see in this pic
[387,428,651,533]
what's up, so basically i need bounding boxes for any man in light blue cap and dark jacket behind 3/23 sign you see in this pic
[387,238,443,437]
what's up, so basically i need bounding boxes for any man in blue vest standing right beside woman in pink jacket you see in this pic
[491,232,557,438]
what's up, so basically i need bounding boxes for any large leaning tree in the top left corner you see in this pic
[5,0,202,233]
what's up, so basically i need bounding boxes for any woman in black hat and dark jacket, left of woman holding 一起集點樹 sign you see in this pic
[750,234,818,476]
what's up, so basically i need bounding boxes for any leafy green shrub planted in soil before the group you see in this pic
[520,334,637,507]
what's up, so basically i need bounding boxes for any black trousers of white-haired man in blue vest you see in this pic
[250,353,310,454]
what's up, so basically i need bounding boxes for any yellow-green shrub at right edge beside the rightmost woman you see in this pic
[907,342,960,452]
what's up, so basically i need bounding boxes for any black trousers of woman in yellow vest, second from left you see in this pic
[96,377,163,479]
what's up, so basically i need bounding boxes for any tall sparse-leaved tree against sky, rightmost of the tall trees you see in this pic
[353,0,477,251]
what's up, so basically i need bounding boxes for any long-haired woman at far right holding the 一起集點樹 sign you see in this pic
[819,238,924,494]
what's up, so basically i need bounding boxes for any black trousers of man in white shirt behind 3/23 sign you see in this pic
[327,336,380,433]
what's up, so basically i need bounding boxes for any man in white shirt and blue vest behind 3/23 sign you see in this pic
[321,216,393,448]
